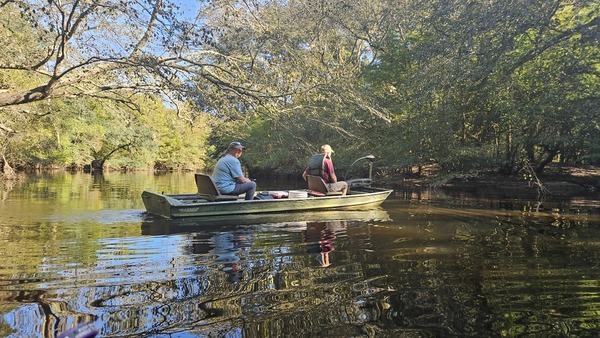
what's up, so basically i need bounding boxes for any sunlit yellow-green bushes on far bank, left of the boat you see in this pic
[4,92,209,169]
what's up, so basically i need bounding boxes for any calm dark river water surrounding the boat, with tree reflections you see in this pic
[0,173,600,337]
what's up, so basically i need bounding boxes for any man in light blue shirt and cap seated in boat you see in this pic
[212,142,256,200]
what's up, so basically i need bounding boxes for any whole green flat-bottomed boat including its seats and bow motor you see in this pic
[142,173,393,218]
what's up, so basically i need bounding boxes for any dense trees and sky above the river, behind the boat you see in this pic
[0,0,600,185]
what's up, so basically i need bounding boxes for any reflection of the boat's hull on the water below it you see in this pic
[142,208,391,235]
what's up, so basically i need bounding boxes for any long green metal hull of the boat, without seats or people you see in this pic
[142,187,393,218]
